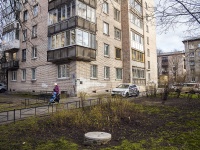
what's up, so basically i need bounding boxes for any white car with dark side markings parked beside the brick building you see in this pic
[111,83,140,97]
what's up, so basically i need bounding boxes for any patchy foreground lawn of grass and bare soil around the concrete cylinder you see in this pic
[0,97,200,150]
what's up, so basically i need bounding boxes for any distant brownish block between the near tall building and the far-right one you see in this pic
[158,51,186,84]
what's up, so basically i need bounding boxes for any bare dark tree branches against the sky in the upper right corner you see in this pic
[155,0,200,36]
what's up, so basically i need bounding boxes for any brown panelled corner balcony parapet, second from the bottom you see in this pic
[48,16,96,36]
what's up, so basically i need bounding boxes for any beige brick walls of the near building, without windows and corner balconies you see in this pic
[1,0,157,95]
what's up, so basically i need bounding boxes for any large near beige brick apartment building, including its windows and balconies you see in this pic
[2,0,157,95]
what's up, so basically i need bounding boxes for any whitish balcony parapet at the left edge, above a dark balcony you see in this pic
[2,40,20,52]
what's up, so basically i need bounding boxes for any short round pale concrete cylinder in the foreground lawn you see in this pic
[84,132,111,145]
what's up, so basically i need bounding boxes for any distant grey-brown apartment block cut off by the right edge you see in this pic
[183,37,200,83]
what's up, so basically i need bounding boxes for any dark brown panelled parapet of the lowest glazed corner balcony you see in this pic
[47,46,96,63]
